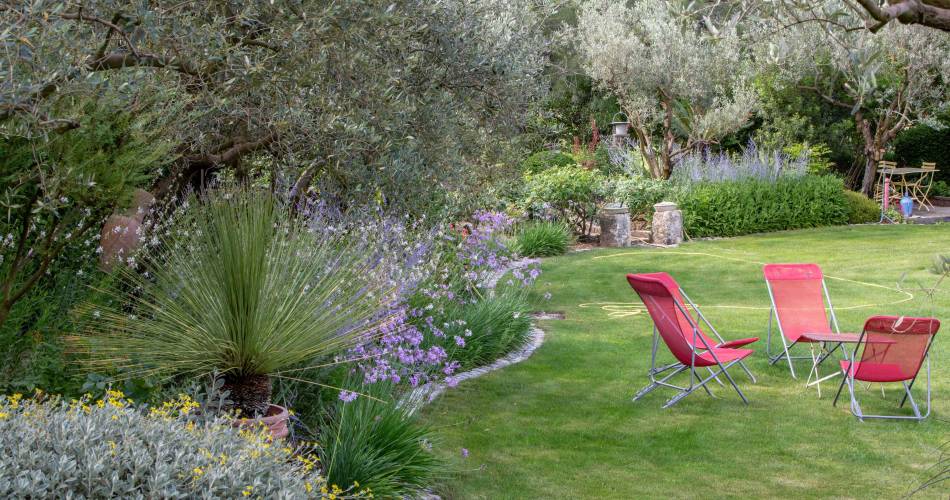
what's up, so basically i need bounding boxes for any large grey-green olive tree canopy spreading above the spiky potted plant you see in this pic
[0,0,554,207]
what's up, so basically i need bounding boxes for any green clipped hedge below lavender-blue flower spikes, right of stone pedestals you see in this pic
[679,176,849,237]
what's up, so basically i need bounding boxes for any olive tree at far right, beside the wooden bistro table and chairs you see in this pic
[763,8,950,194]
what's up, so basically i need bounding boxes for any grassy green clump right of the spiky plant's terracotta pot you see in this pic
[319,383,442,498]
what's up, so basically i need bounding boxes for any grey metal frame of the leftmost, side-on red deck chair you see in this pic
[633,287,756,408]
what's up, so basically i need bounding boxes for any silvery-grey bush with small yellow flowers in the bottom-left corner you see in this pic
[0,391,346,498]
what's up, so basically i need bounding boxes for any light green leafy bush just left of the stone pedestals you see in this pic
[522,166,604,235]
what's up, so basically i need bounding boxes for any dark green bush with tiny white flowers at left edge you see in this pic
[0,95,181,334]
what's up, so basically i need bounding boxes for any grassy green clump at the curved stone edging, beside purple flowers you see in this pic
[427,288,531,370]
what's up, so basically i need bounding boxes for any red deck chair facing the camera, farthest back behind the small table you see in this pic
[762,264,844,378]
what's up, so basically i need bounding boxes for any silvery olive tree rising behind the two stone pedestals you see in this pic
[574,0,756,178]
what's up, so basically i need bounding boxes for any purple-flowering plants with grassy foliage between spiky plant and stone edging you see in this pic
[303,202,541,392]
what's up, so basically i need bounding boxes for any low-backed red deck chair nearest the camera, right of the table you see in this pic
[834,316,940,421]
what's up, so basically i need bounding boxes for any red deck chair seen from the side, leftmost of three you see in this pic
[627,273,758,408]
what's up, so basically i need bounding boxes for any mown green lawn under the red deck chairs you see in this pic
[425,225,950,499]
